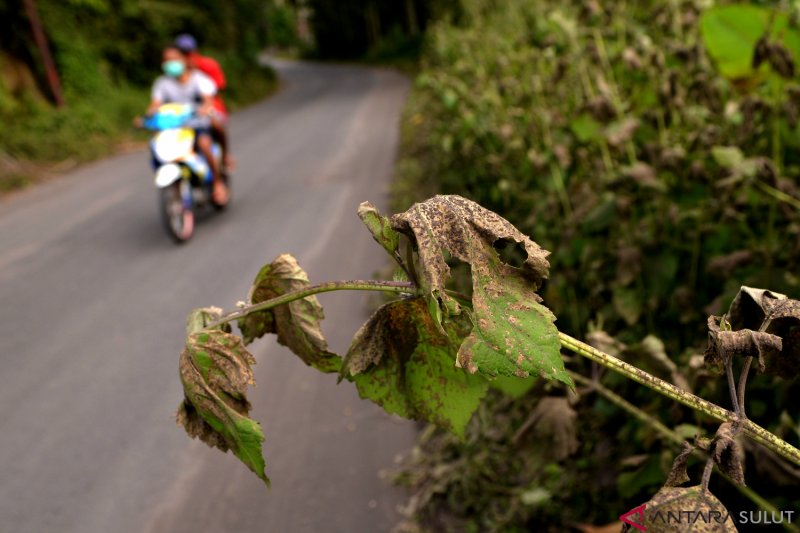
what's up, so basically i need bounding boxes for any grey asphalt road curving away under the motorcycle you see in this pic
[0,59,414,533]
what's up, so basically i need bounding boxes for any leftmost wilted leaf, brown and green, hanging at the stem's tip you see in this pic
[177,326,269,485]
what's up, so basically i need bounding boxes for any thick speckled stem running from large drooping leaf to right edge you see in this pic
[558,332,800,465]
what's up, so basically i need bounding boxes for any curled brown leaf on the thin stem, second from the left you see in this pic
[238,254,341,372]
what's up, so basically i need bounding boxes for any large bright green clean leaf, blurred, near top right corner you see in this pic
[700,4,770,79]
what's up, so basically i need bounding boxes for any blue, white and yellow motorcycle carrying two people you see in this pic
[142,104,230,243]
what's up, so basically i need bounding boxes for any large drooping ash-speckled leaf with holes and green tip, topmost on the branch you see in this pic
[391,196,572,386]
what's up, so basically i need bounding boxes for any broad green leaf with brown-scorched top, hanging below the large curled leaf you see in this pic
[343,298,488,436]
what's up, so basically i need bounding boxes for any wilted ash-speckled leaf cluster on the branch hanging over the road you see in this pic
[178,196,572,480]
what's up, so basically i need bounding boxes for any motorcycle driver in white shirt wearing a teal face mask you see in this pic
[147,46,228,205]
